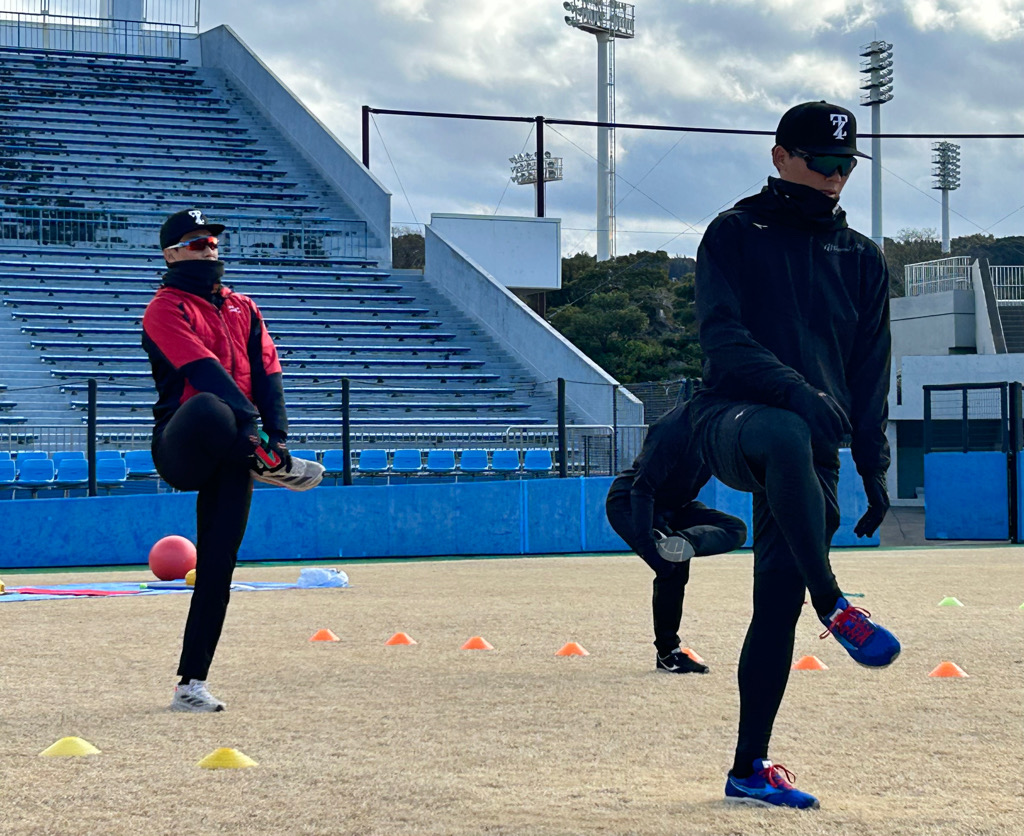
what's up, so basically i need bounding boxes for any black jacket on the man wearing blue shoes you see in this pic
[693,177,891,475]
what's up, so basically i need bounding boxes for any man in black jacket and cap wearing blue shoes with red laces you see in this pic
[693,101,900,807]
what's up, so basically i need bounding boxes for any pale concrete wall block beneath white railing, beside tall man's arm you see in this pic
[890,290,975,367]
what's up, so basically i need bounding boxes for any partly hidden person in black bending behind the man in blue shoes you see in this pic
[605,404,746,673]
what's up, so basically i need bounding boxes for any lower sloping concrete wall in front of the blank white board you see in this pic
[423,226,643,426]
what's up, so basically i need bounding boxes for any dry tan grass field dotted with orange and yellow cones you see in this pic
[0,547,1024,836]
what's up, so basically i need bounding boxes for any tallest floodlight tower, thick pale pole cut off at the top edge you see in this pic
[562,0,634,261]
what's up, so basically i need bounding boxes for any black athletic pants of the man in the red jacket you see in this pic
[153,392,253,679]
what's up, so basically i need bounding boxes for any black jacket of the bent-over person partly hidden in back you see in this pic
[608,404,711,556]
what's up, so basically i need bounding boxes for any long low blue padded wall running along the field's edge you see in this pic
[0,468,880,569]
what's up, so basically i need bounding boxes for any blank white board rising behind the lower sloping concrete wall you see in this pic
[430,214,562,290]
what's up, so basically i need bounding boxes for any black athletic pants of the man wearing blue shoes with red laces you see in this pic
[702,405,841,778]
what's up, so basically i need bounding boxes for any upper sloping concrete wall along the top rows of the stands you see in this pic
[200,26,391,259]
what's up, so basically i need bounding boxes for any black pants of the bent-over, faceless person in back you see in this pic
[605,492,746,656]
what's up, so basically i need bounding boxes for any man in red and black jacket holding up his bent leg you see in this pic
[142,209,324,712]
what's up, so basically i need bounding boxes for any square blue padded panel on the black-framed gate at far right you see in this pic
[925,453,1010,540]
